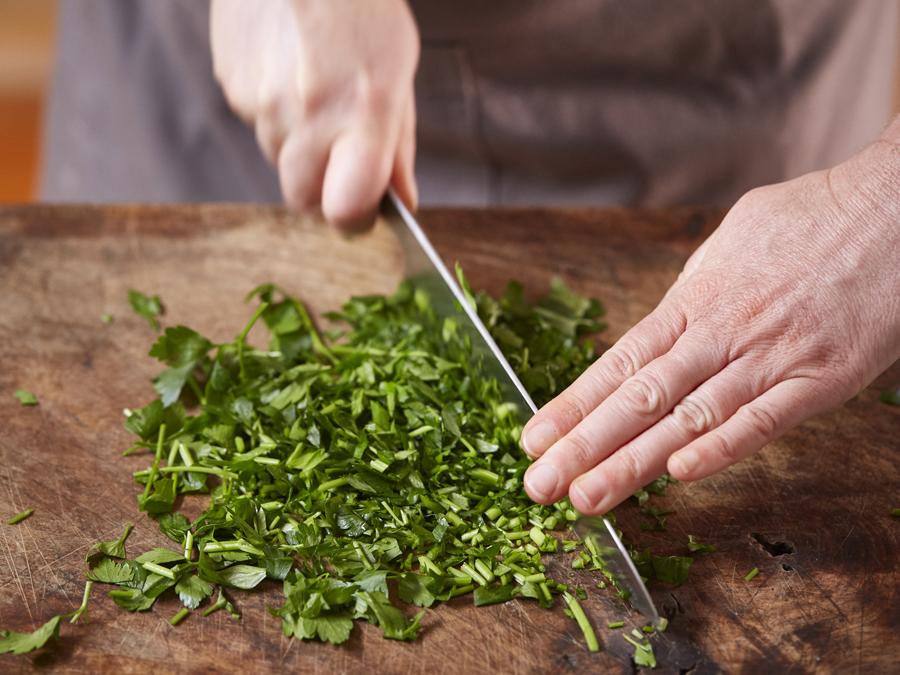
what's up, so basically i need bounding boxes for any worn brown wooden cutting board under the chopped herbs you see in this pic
[0,206,900,675]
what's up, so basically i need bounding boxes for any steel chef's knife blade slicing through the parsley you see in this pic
[381,188,661,628]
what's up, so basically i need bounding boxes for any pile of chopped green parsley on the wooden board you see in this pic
[0,275,711,664]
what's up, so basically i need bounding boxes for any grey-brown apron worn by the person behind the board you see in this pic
[43,0,897,205]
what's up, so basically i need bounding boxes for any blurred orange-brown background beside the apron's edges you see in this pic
[0,0,900,203]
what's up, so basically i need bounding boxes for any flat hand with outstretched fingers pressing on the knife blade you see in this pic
[522,129,900,514]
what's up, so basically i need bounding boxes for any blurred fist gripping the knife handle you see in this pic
[210,0,419,231]
